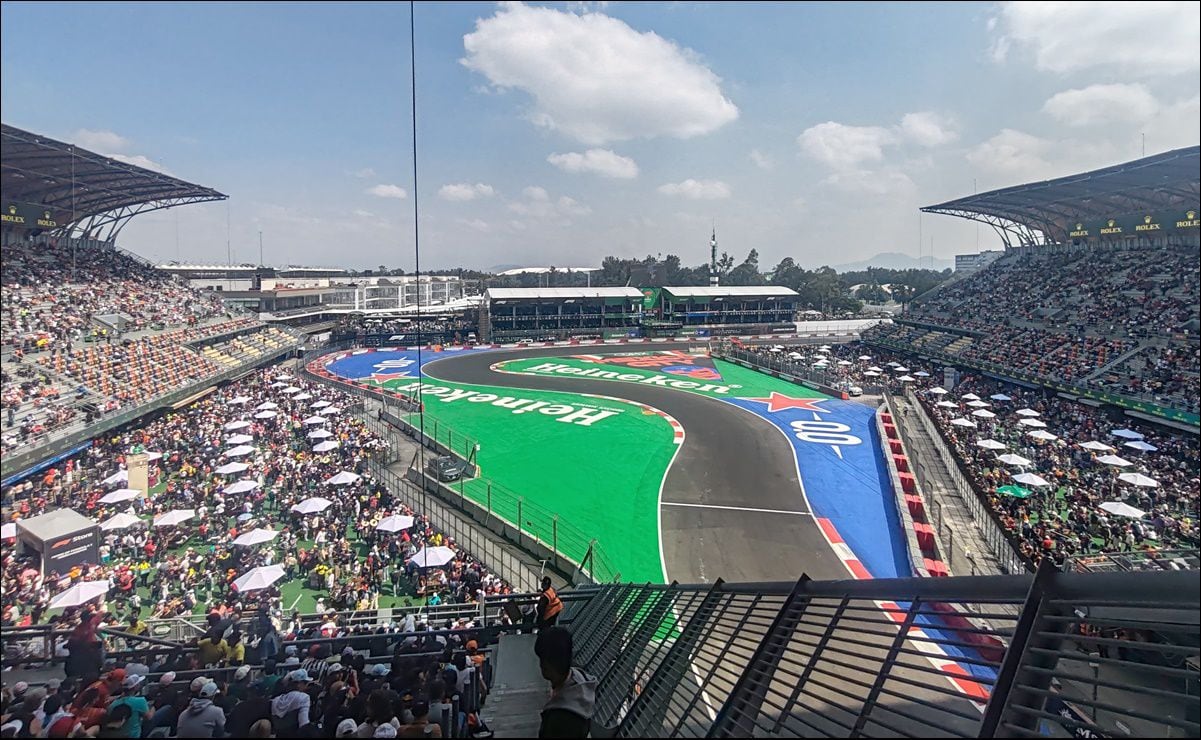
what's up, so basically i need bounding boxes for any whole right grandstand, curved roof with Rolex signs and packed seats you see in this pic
[865,147,1201,428]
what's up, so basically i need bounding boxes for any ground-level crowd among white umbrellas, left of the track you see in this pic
[2,370,508,643]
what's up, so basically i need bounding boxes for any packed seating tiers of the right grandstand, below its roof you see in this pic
[865,246,1201,413]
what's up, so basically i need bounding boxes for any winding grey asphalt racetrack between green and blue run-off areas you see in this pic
[424,344,849,583]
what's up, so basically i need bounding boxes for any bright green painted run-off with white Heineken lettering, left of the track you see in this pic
[383,378,676,583]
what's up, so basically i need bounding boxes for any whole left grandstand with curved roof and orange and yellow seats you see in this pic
[0,125,298,476]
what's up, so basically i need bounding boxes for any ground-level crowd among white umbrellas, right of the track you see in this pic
[918,376,1201,563]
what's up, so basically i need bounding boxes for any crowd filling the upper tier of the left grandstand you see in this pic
[0,240,226,352]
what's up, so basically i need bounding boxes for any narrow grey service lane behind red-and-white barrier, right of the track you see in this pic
[892,395,1004,575]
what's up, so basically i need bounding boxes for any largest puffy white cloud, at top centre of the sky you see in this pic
[461,2,739,145]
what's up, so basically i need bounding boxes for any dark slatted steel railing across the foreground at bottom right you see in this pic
[562,563,1201,738]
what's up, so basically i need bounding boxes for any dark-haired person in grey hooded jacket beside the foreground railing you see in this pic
[533,627,597,738]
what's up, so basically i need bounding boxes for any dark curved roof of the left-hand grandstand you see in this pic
[0,124,228,239]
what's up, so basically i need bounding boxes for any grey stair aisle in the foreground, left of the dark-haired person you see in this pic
[480,634,550,738]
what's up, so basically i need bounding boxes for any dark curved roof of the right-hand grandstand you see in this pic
[921,147,1201,244]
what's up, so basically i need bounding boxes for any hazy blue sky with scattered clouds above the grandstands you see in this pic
[0,2,1201,269]
